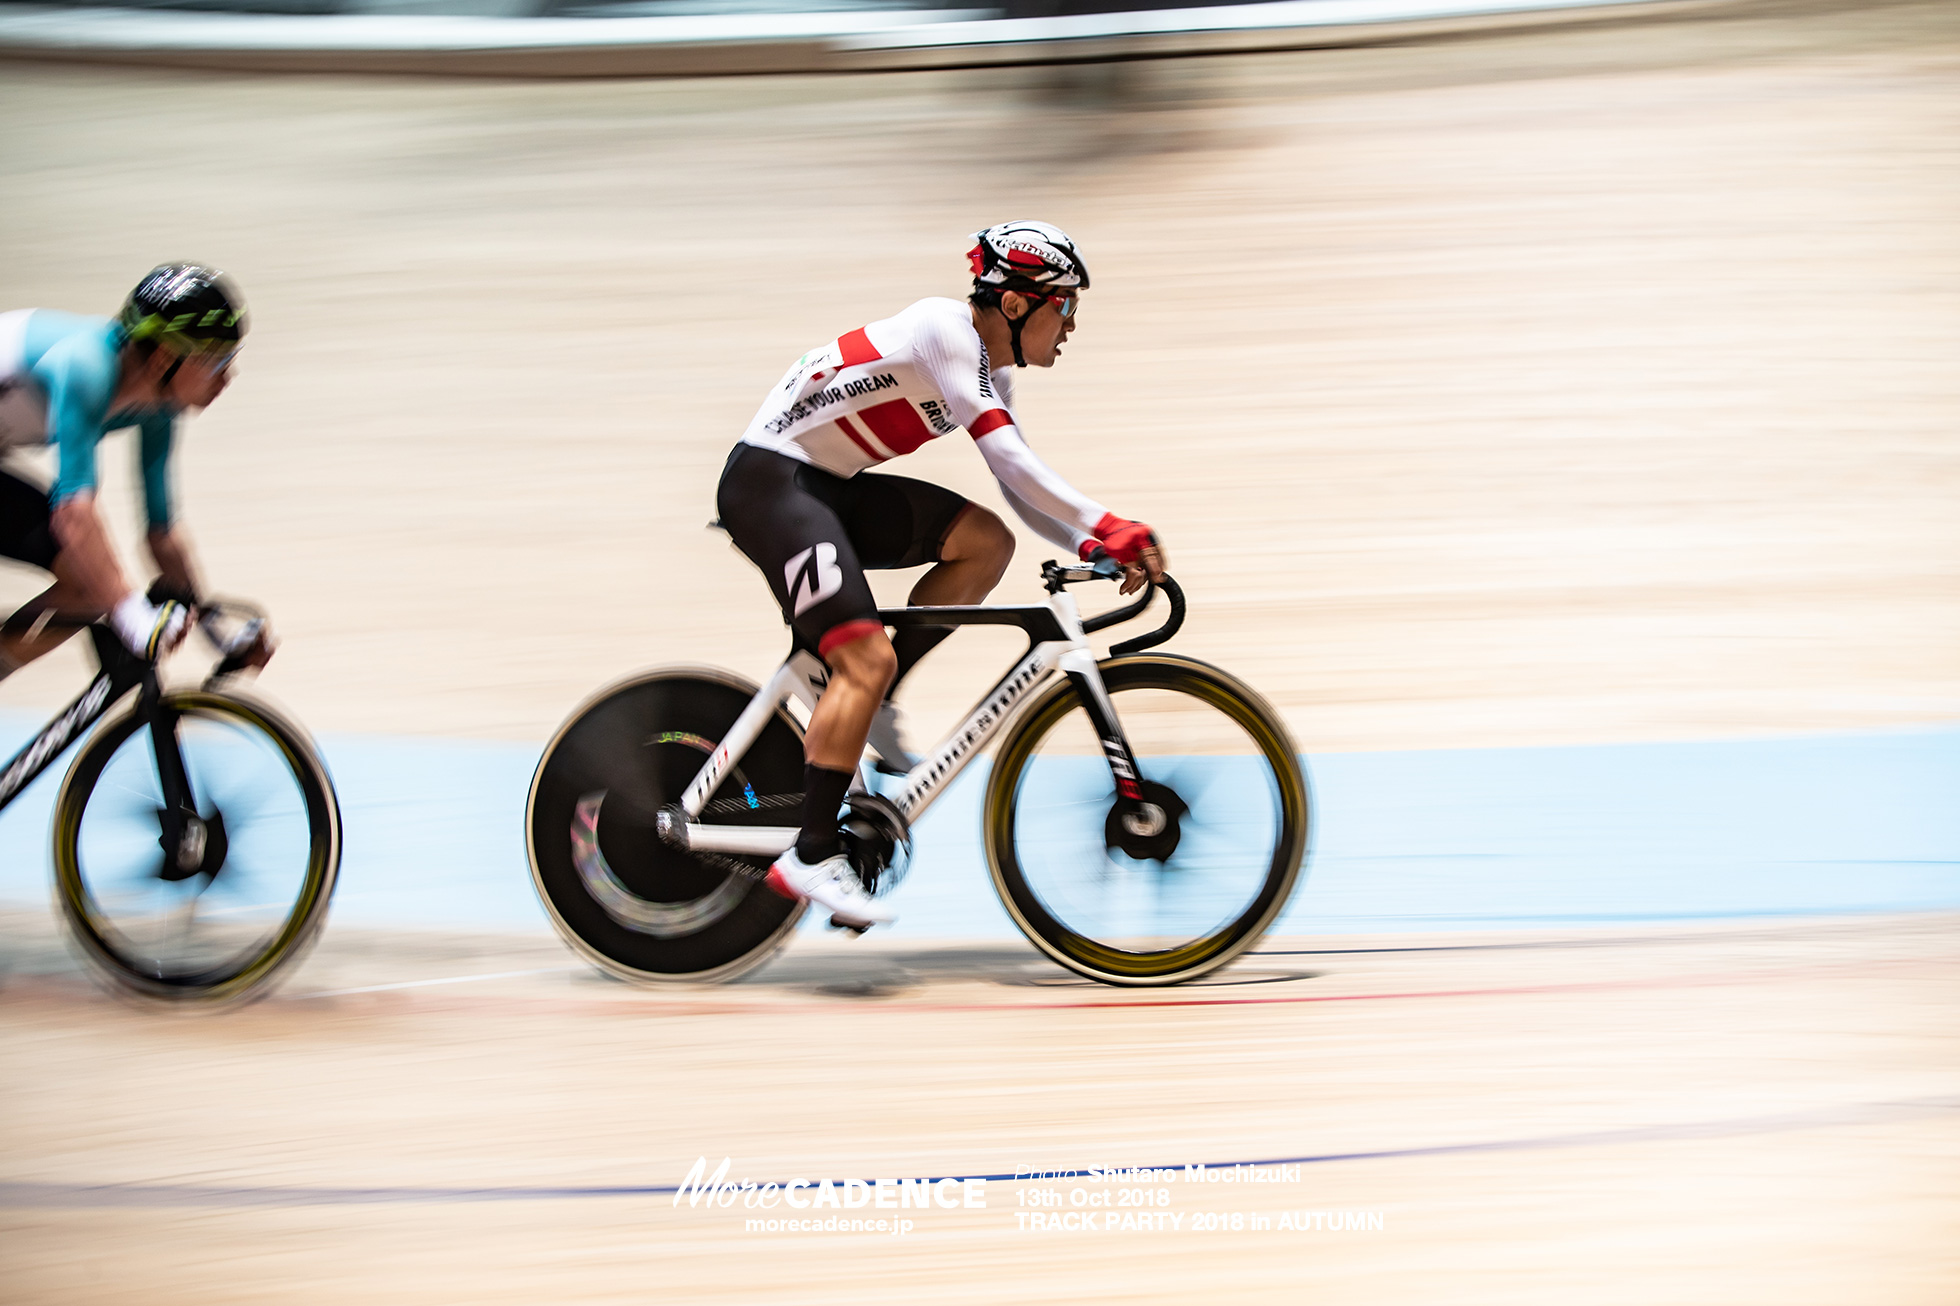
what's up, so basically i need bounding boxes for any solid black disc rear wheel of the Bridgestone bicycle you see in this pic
[527,667,804,982]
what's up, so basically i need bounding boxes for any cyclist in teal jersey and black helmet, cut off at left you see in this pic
[0,263,272,677]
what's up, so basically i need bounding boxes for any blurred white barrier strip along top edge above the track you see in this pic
[0,0,1760,76]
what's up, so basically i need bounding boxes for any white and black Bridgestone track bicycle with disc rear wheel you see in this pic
[525,559,1309,984]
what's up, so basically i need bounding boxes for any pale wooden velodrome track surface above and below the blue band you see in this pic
[0,4,1960,1306]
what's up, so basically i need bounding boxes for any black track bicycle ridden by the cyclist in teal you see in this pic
[0,600,341,1006]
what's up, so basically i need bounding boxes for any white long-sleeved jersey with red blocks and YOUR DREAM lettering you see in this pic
[743,298,1105,549]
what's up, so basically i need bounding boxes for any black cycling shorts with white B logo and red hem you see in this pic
[715,445,968,657]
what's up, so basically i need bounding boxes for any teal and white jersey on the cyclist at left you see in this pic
[0,308,176,529]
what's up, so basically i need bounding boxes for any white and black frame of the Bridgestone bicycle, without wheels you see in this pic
[662,590,1135,857]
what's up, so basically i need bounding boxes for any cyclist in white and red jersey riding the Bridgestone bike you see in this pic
[717,222,1164,928]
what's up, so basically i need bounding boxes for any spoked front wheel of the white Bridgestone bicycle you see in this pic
[984,653,1311,984]
